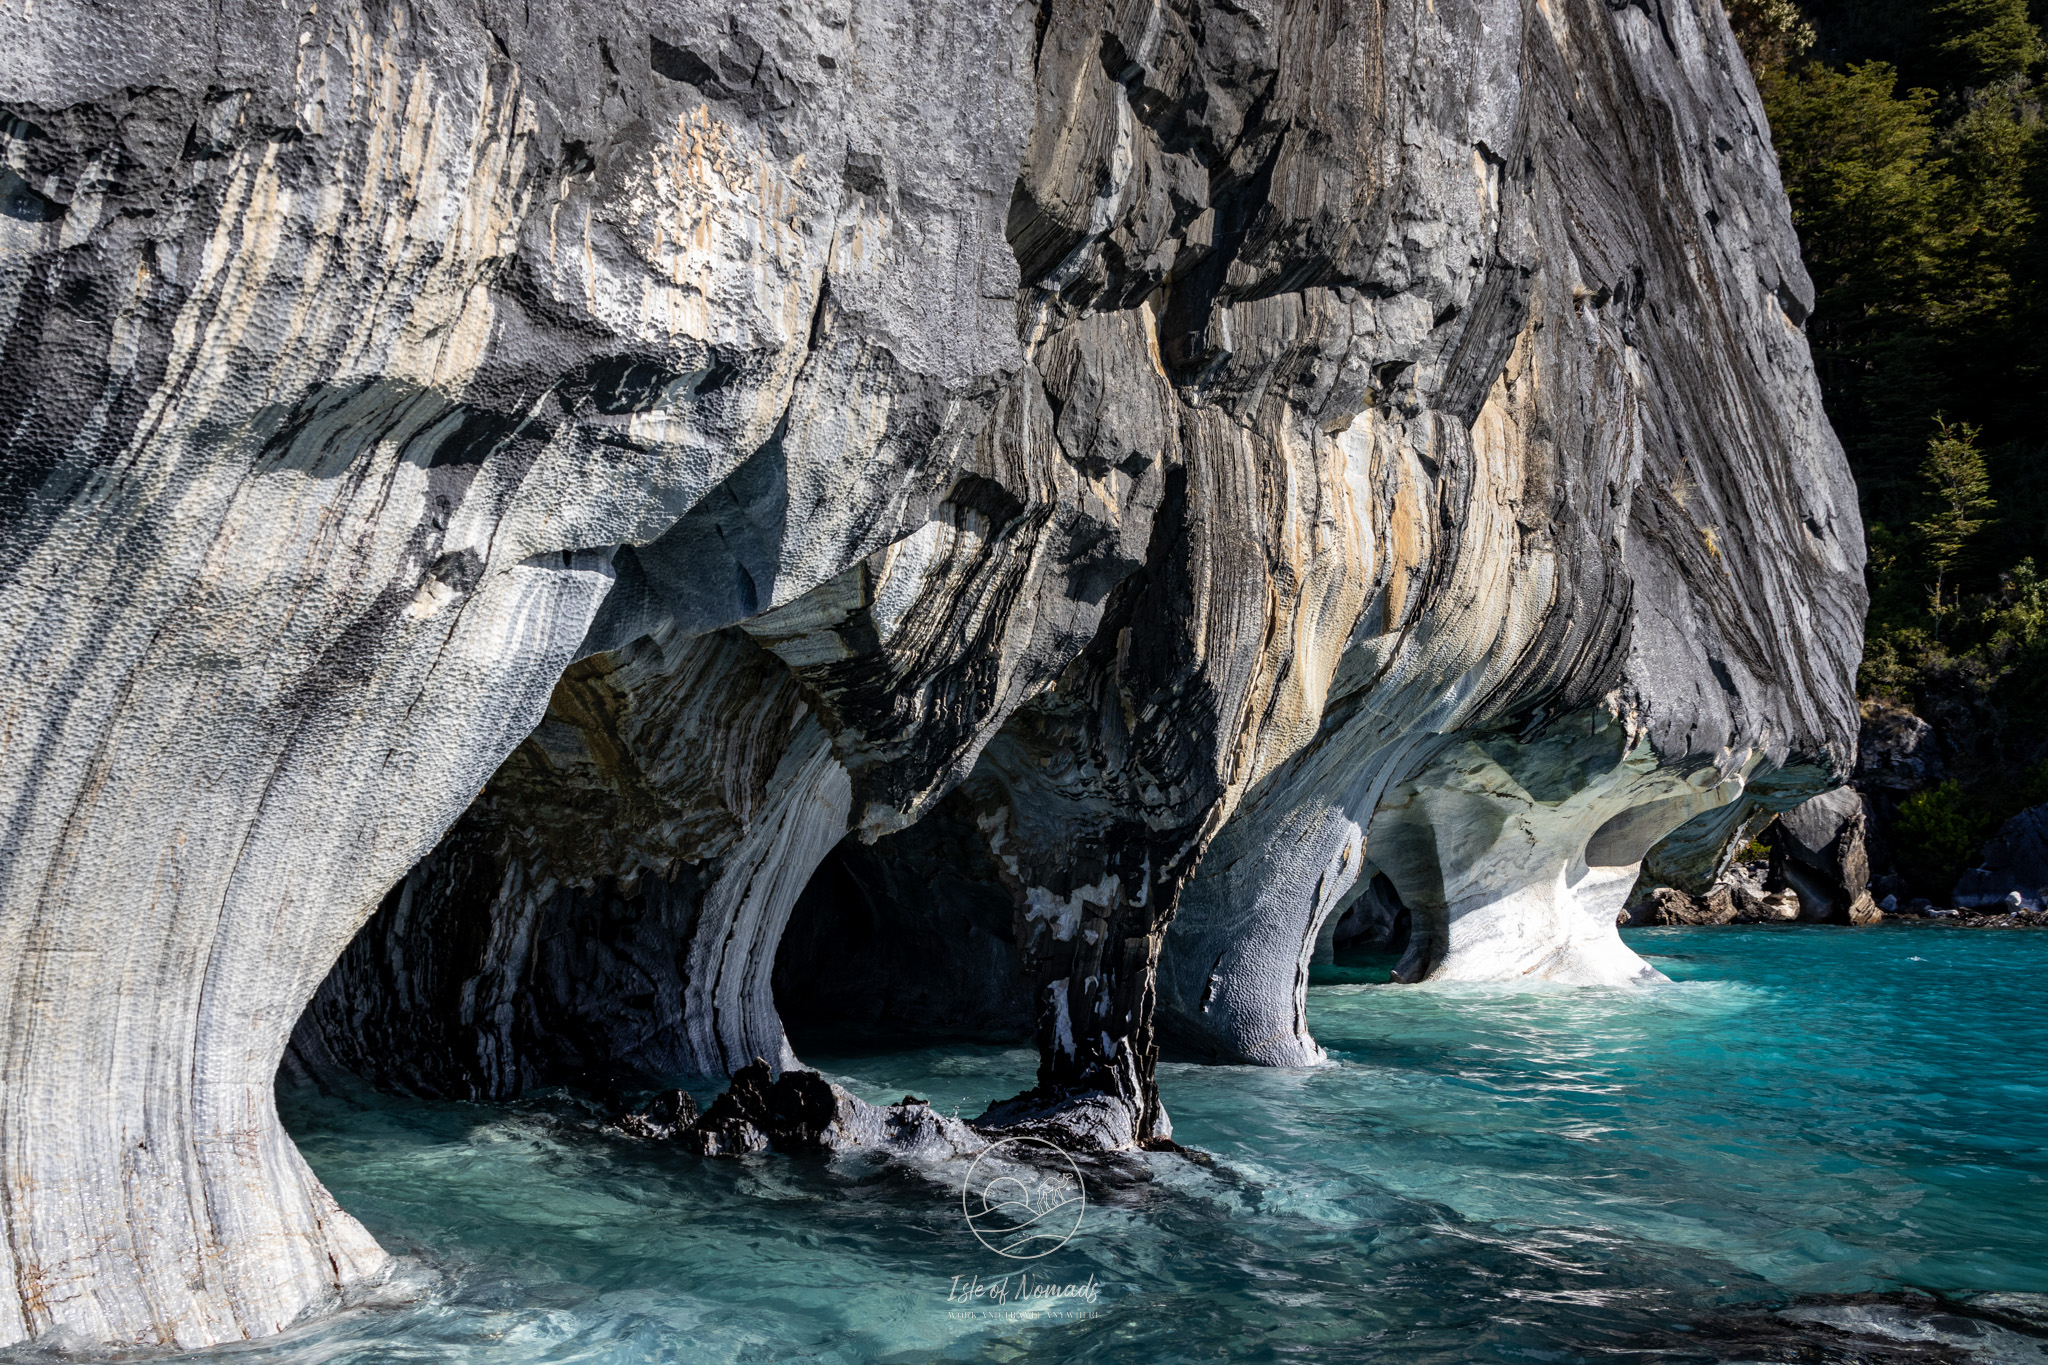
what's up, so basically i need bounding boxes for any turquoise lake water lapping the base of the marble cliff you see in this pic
[235,927,2048,1365]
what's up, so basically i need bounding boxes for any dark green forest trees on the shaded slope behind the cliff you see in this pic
[1729,0,2048,896]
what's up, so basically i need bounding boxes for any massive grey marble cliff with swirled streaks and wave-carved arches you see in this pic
[0,0,1862,1347]
